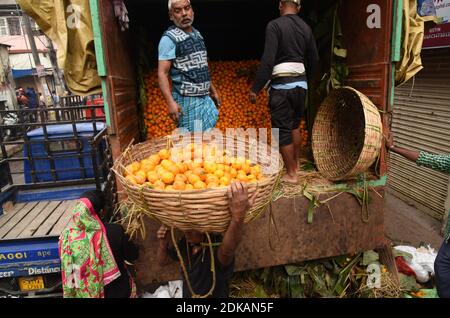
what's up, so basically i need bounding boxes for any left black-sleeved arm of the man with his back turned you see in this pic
[251,23,278,94]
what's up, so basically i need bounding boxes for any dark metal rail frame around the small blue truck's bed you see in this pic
[0,96,115,201]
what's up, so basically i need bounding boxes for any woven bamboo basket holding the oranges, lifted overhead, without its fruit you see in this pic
[113,135,283,233]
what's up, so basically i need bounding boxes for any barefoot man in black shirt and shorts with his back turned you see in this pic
[249,0,319,183]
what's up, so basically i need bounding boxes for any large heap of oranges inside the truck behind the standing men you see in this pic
[144,60,271,139]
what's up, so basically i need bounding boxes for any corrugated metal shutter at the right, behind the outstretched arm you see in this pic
[389,48,450,219]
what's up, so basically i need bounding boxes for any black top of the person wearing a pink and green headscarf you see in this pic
[105,223,139,298]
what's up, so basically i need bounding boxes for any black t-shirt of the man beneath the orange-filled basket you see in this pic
[168,238,234,298]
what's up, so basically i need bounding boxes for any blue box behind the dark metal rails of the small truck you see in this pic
[23,122,106,183]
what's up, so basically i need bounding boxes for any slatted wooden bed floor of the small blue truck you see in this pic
[0,200,76,240]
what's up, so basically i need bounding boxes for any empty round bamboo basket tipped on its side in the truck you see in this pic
[312,87,383,181]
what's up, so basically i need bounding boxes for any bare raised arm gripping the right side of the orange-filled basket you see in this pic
[217,182,250,266]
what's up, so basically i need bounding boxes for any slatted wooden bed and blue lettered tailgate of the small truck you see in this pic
[0,200,76,278]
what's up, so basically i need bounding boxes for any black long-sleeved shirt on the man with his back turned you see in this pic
[252,14,319,93]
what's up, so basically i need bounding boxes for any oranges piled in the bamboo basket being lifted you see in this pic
[124,144,264,191]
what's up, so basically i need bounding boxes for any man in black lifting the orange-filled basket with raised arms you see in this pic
[157,182,251,298]
